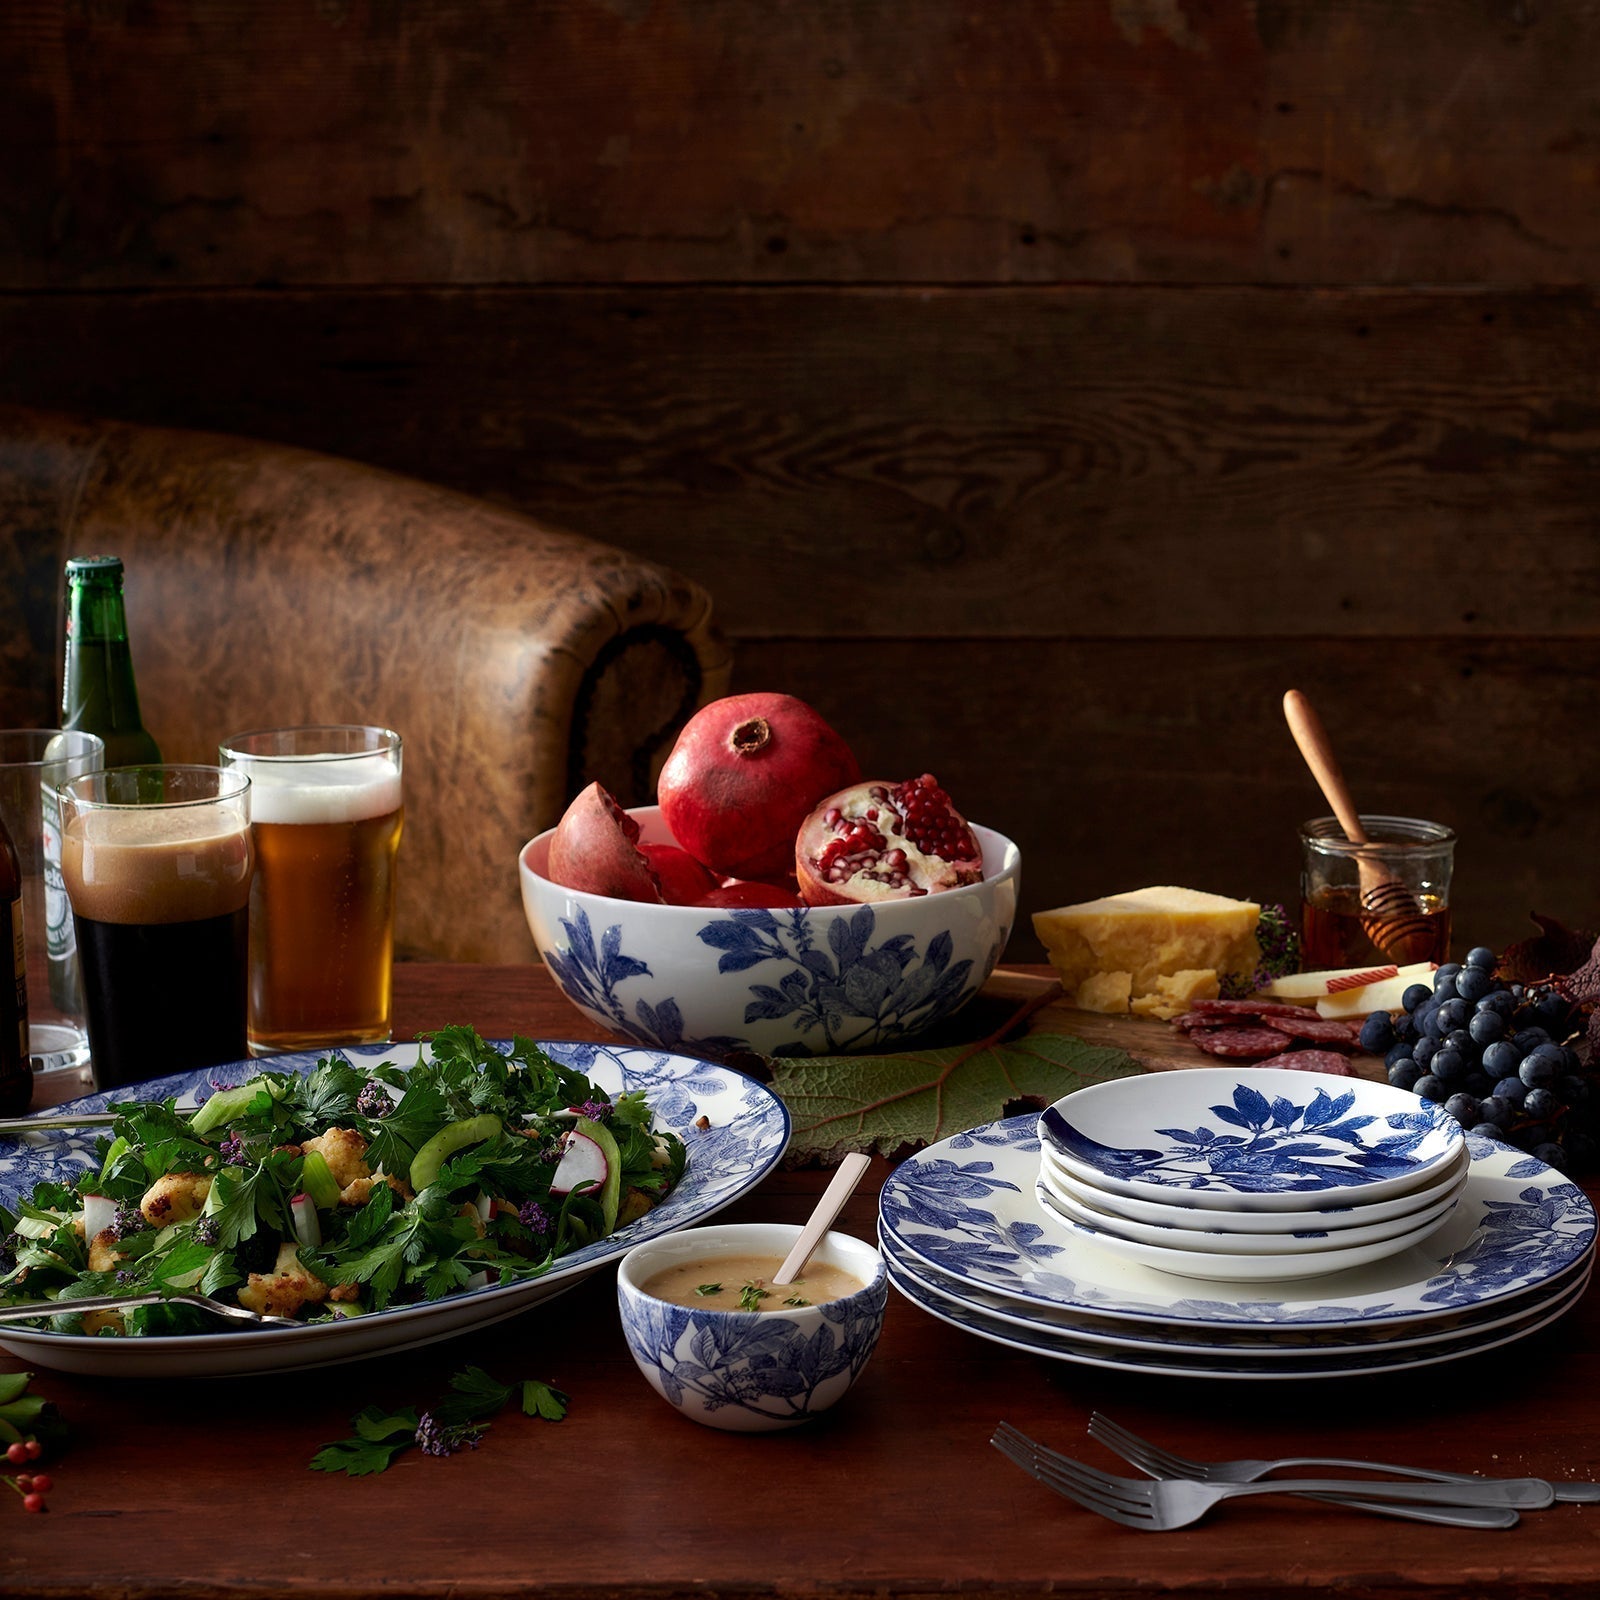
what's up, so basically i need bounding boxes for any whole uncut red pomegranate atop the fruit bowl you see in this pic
[656,694,861,878]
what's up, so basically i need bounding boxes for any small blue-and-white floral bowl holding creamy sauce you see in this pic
[616,1222,890,1434]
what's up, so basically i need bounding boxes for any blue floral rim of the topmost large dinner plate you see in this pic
[878,1117,1595,1326]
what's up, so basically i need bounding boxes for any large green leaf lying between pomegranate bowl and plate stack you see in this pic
[771,1032,1144,1165]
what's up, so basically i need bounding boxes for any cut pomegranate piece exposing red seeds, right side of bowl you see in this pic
[795,773,984,906]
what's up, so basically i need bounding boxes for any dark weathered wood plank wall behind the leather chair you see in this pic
[0,0,1600,957]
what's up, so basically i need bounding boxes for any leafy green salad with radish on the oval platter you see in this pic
[0,1027,686,1336]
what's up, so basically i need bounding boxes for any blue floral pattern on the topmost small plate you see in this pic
[1040,1082,1462,1195]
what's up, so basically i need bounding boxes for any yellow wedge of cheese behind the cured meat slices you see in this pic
[1034,886,1261,1000]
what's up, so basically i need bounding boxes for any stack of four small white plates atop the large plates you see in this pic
[1037,1067,1469,1282]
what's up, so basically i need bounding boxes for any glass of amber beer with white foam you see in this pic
[221,725,405,1054]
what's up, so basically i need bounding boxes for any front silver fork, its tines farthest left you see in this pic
[990,1422,1550,1533]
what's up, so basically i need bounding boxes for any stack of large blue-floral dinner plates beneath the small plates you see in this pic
[878,1069,1595,1379]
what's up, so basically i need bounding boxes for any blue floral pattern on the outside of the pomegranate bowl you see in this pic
[544,906,985,1056]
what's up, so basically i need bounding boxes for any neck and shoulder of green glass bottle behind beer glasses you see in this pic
[61,555,162,766]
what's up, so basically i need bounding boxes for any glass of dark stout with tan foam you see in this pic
[58,766,254,1090]
